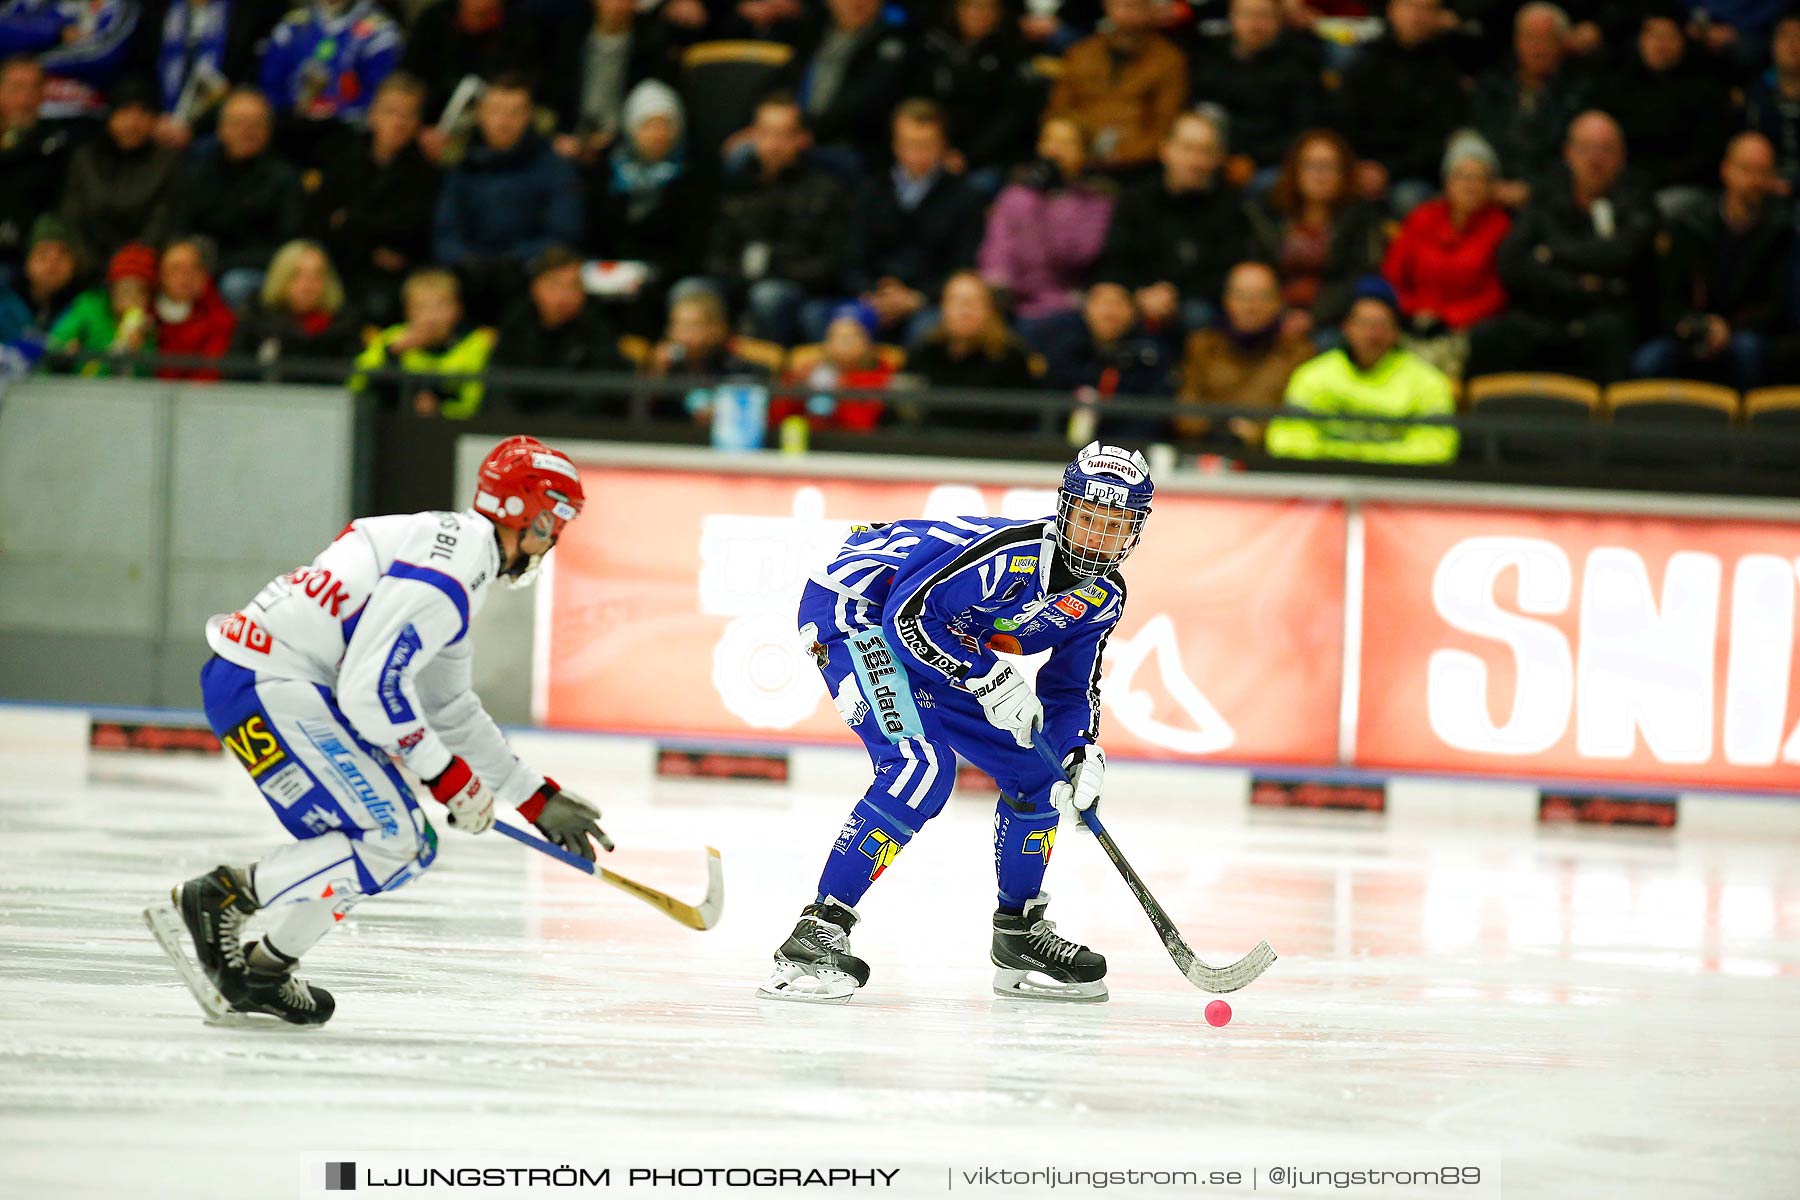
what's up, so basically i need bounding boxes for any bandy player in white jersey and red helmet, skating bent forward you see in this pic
[146,437,612,1025]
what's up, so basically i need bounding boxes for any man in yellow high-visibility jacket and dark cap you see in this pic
[1265,288,1460,466]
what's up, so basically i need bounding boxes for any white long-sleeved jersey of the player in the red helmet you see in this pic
[207,509,544,804]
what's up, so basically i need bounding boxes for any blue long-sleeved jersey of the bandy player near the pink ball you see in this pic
[812,516,1125,757]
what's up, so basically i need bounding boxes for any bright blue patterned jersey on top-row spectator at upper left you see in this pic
[263,0,400,119]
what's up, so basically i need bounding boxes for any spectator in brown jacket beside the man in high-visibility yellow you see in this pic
[1175,263,1314,446]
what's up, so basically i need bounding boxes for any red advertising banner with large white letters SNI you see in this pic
[1355,504,1800,790]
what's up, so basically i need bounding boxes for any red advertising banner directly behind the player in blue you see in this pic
[535,466,1345,765]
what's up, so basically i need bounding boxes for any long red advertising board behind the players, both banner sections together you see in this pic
[511,444,1800,795]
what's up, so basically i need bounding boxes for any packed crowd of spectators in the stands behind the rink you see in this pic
[0,0,1800,462]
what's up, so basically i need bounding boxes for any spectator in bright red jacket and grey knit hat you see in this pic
[1381,131,1512,376]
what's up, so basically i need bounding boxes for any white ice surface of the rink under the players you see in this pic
[0,739,1800,1198]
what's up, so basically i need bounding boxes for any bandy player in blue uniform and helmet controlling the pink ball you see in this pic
[758,443,1152,1004]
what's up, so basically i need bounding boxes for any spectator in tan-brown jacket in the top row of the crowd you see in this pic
[1044,0,1188,171]
